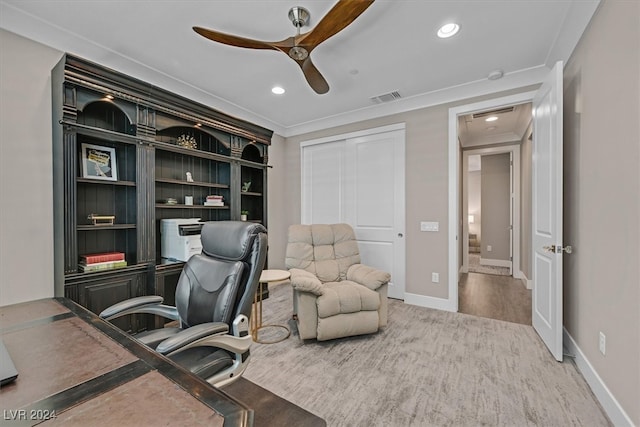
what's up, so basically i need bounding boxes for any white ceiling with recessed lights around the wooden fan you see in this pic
[0,0,599,136]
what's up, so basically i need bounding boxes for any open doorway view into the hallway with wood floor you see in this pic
[458,102,531,325]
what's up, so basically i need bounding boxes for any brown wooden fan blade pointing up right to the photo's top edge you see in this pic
[298,0,374,50]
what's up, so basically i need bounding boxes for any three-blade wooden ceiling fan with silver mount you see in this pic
[193,0,374,94]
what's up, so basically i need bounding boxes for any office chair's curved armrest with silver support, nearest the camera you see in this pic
[156,315,253,356]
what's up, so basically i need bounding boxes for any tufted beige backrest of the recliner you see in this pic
[285,224,360,283]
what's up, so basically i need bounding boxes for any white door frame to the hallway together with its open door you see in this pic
[450,61,565,361]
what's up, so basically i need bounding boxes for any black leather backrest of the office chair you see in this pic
[176,221,267,327]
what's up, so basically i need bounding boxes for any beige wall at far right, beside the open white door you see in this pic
[564,0,640,425]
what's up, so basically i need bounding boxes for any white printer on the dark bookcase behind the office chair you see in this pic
[160,218,203,261]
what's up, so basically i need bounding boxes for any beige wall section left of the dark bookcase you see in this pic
[0,29,62,306]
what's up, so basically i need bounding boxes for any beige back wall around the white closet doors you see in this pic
[269,87,534,298]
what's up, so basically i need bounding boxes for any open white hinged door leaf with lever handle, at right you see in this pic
[531,62,563,361]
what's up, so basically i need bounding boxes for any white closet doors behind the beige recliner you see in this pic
[301,125,405,299]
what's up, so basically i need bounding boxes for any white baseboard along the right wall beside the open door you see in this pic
[563,328,634,427]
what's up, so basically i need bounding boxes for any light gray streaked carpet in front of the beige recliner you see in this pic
[244,282,610,427]
